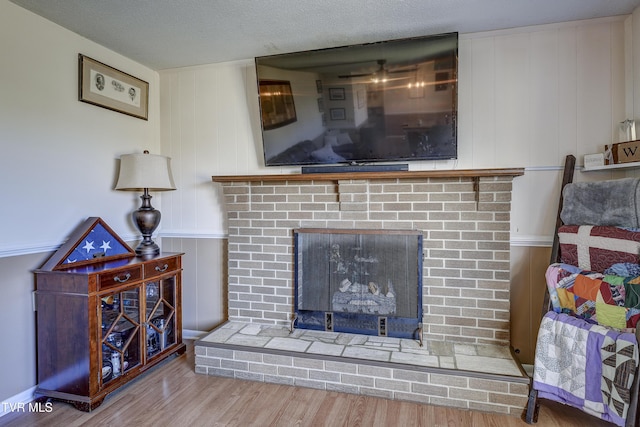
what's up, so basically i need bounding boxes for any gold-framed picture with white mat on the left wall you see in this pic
[78,54,149,120]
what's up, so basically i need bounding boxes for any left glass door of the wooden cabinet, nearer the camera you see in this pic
[100,287,141,383]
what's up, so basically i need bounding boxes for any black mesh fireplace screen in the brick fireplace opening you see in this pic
[294,229,422,339]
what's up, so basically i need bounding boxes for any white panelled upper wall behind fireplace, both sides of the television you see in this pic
[160,17,631,245]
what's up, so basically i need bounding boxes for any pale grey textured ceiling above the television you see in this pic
[11,0,640,70]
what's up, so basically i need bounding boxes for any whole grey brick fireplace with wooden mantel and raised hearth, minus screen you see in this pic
[202,169,528,415]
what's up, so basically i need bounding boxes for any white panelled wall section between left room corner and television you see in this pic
[160,60,264,237]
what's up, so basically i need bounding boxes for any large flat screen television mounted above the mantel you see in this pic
[255,33,458,166]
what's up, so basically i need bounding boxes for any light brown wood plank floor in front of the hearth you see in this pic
[0,342,611,427]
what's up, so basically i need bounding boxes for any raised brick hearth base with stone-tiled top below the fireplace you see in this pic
[195,322,529,416]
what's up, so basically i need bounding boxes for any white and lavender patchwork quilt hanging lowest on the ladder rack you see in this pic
[533,311,638,426]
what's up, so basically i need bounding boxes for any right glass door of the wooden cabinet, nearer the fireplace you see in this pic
[145,276,176,357]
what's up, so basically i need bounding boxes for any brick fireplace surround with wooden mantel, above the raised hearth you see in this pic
[214,169,523,345]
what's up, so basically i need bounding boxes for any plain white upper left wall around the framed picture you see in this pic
[0,1,160,256]
